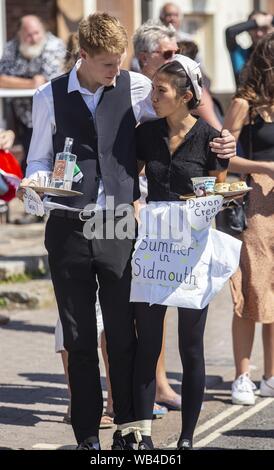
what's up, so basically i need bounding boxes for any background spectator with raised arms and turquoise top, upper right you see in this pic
[225,10,274,85]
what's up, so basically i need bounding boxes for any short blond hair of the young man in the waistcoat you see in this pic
[78,13,128,57]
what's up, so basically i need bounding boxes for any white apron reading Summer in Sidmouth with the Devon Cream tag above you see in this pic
[130,201,241,309]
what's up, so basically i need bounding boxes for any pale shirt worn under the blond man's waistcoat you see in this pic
[26,59,156,210]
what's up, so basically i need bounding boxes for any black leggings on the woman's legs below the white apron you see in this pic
[133,303,208,440]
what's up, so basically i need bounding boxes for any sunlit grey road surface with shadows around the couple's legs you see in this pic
[0,201,274,450]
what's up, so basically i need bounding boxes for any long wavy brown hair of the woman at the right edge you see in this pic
[235,33,274,110]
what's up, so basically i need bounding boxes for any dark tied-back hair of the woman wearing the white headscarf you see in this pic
[155,60,202,110]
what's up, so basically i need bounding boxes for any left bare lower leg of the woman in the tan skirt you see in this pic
[232,315,255,378]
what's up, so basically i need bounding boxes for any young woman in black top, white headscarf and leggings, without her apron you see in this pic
[133,55,228,450]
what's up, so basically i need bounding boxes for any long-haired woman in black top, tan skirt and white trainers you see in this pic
[225,33,274,405]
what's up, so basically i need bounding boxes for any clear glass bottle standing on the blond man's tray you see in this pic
[51,137,77,190]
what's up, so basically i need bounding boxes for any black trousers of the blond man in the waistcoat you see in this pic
[45,215,136,443]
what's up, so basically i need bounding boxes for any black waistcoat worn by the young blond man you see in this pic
[52,70,140,208]
